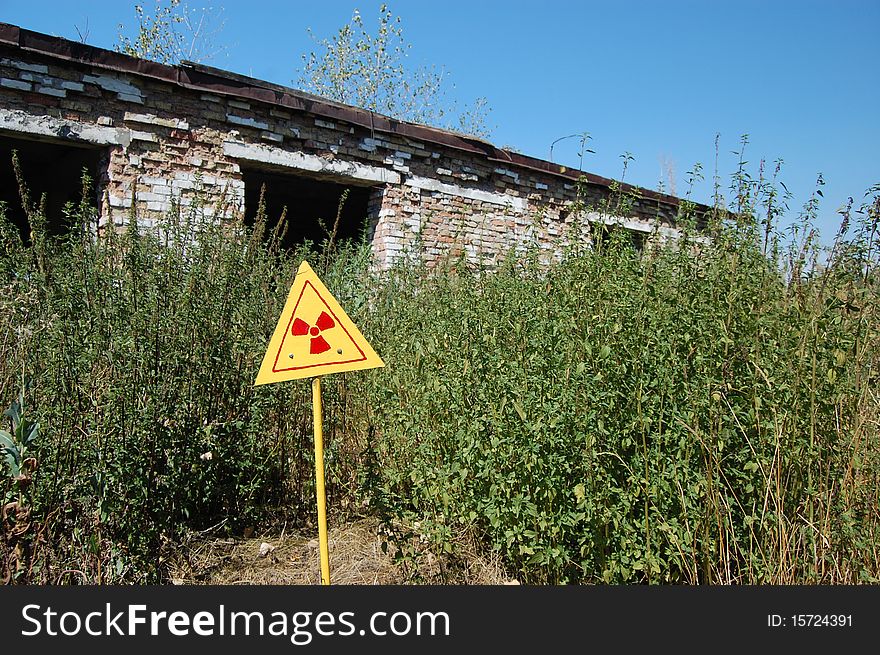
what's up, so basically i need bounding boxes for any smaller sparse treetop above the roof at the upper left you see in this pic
[116,0,226,65]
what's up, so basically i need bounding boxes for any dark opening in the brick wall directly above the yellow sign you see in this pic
[241,166,372,248]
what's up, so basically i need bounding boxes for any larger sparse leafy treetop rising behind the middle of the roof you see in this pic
[297,4,489,137]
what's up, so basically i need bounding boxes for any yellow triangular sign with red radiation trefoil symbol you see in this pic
[255,262,385,385]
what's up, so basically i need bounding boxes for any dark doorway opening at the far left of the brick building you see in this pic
[0,135,104,244]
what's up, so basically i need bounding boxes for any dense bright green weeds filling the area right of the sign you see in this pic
[370,188,880,584]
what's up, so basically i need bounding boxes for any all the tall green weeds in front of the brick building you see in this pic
[0,152,880,584]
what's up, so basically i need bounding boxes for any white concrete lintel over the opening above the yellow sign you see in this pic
[223,141,400,184]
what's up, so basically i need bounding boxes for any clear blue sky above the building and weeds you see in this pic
[0,0,880,242]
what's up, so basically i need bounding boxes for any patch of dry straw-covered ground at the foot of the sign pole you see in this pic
[171,519,517,585]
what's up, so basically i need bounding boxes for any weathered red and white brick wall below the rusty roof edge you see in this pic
[0,25,688,265]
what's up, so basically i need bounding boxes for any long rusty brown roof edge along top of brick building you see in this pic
[0,22,711,211]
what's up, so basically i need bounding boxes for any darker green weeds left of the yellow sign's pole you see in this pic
[0,172,378,582]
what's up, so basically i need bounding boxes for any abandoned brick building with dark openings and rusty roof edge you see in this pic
[0,23,700,266]
